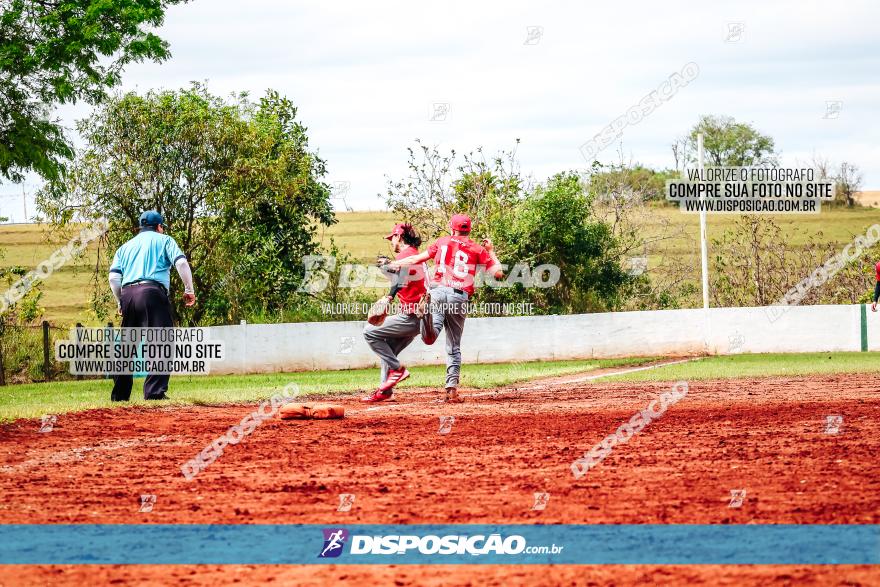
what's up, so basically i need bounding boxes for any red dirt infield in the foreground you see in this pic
[0,375,880,585]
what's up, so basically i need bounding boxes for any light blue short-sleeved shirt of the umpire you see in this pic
[110,230,186,290]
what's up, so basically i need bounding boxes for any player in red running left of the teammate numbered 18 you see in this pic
[361,223,427,402]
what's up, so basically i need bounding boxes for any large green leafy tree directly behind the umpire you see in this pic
[38,84,335,323]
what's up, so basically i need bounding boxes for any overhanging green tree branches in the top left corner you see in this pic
[0,0,186,181]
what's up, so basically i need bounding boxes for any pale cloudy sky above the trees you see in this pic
[0,0,880,219]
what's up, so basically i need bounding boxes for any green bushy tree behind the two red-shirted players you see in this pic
[386,141,632,314]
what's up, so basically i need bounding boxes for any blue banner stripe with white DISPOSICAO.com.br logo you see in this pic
[0,524,880,565]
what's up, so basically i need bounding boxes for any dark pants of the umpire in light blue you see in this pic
[110,282,174,401]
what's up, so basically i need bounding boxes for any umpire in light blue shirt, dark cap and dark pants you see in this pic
[110,210,196,401]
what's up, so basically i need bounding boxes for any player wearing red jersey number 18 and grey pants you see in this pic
[389,214,504,403]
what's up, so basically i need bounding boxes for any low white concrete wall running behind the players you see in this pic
[203,305,868,374]
